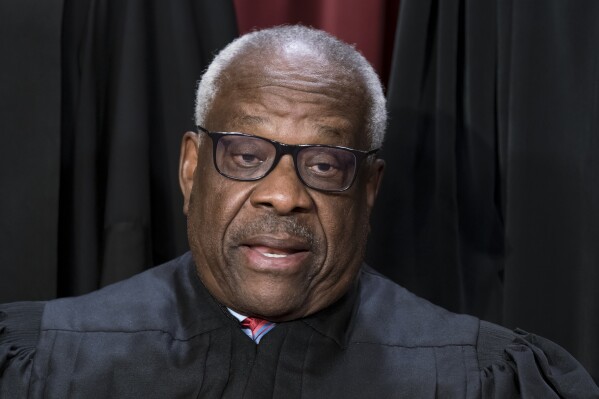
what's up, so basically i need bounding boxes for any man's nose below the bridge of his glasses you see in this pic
[250,155,314,215]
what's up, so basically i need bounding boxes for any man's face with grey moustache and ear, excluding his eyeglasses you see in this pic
[181,49,383,321]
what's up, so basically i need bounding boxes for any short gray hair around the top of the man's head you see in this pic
[195,25,387,148]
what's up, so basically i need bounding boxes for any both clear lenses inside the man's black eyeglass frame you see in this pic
[215,135,356,191]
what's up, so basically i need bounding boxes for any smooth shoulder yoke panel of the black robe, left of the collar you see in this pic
[41,253,209,340]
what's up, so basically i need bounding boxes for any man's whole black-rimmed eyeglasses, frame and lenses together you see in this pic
[197,126,378,192]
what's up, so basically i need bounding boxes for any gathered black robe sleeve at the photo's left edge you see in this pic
[0,302,45,398]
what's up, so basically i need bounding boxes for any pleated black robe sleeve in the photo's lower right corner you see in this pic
[477,322,599,399]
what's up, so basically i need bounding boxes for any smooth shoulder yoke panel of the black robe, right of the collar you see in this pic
[353,266,479,347]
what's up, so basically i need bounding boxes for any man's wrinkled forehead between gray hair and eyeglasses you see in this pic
[206,48,366,145]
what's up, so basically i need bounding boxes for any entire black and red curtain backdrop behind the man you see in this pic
[0,0,599,380]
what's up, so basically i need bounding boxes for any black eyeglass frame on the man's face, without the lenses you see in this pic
[196,125,380,193]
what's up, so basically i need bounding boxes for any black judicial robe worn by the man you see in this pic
[0,253,599,399]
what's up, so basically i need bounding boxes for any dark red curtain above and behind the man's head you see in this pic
[234,0,399,84]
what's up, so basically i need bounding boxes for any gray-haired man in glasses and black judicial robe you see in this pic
[0,26,599,398]
